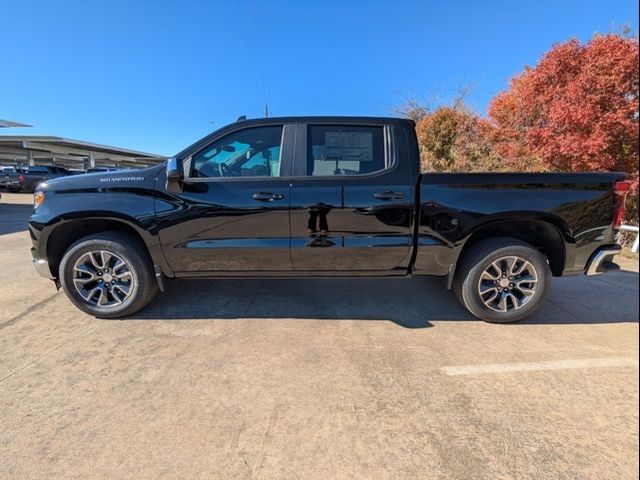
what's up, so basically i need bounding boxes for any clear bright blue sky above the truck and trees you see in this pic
[0,0,638,155]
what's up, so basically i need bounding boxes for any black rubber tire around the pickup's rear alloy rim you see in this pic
[453,237,551,323]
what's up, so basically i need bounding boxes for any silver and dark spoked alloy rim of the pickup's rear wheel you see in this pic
[478,256,538,313]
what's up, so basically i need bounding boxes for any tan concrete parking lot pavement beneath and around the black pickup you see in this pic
[0,192,639,479]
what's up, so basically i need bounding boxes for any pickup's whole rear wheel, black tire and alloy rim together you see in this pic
[453,237,551,323]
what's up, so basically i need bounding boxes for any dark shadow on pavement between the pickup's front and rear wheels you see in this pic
[129,278,473,328]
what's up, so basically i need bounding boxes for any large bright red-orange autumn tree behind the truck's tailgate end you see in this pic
[488,34,638,192]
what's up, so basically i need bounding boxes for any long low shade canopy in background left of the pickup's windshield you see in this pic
[0,135,166,170]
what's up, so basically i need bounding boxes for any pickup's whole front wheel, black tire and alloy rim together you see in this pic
[59,232,158,318]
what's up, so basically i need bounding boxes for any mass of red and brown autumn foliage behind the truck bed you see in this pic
[400,31,639,223]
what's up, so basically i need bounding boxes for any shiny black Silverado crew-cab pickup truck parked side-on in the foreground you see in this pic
[29,117,629,322]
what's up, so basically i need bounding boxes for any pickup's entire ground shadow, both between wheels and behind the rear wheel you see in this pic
[129,272,638,328]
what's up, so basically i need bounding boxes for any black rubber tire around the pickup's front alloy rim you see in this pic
[59,232,158,318]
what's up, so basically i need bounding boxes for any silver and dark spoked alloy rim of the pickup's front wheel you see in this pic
[73,250,135,307]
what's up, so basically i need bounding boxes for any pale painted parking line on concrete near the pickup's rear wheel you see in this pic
[440,357,638,375]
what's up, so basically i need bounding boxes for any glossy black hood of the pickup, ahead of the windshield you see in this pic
[37,163,165,192]
